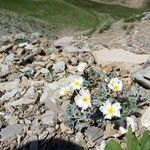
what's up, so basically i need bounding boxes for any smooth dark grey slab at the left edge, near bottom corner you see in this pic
[0,124,23,140]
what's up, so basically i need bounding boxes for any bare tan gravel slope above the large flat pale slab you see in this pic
[93,12,150,54]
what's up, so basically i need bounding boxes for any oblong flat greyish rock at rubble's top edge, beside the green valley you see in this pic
[54,36,74,48]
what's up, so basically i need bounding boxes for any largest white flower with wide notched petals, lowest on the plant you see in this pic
[100,101,121,119]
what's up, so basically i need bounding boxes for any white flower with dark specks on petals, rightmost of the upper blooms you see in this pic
[108,78,123,92]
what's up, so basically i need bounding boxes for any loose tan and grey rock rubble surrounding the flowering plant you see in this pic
[0,29,150,150]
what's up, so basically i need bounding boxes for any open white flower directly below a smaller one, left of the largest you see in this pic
[75,89,91,110]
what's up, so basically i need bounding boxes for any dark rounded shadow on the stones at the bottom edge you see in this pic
[17,138,84,150]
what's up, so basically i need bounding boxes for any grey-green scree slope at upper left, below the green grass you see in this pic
[0,10,57,45]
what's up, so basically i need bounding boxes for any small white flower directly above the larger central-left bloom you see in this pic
[71,77,83,90]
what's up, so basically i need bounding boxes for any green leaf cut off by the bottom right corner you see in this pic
[139,131,150,150]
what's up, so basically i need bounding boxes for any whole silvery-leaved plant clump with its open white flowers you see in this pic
[64,67,146,132]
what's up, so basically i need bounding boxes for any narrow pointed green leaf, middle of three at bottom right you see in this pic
[126,127,143,150]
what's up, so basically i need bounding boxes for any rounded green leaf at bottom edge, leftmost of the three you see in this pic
[105,140,122,150]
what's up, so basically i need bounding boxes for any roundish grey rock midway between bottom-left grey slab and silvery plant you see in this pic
[40,111,57,127]
